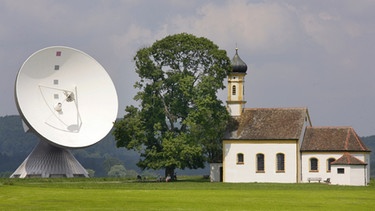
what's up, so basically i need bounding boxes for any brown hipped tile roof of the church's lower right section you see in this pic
[301,127,370,152]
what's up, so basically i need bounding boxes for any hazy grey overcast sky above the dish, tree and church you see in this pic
[0,0,375,136]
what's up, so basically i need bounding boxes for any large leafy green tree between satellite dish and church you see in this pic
[113,33,231,175]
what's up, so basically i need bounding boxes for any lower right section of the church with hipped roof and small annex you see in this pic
[301,127,370,185]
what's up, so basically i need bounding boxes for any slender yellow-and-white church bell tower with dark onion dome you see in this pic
[227,48,247,117]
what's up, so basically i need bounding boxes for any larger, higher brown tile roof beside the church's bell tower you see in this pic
[225,108,310,140]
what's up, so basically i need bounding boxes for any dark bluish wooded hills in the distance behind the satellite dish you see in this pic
[0,115,209,178]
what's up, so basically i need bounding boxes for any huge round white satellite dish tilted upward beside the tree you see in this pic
[11,46,118,178]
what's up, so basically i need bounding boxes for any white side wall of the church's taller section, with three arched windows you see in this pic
[223,141,297,183]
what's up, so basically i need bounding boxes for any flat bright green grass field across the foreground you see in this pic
[0,177,375,211]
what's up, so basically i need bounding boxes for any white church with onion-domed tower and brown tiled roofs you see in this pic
[210,49,370,186]
